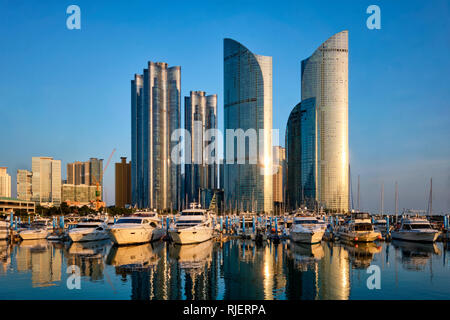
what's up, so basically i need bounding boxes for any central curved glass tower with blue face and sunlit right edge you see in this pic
[224,39,273,213]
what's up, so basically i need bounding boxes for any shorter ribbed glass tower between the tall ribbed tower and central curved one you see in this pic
[184,91,217,202]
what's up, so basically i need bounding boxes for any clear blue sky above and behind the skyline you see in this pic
[0,0,450,212]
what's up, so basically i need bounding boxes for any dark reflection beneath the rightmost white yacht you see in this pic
[392,240,441,271]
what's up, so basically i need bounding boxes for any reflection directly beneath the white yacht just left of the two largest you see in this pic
[66,240,112,281]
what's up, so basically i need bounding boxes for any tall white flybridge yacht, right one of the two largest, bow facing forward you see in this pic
[169,204,214,244]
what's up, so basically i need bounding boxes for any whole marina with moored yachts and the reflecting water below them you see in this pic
[0,210,450,300]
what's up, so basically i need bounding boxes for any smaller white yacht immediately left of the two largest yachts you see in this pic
[67,219,109,242]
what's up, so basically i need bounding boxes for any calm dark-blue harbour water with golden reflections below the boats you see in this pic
[0,240,450,299]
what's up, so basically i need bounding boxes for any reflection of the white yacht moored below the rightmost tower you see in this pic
[288,241,325,271]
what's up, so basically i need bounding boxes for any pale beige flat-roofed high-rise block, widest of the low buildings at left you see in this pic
[31,157,61,205]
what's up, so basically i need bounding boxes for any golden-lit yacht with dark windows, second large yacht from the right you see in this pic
[337,213,381,242]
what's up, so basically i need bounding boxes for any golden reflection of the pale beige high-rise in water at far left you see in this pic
[12,240,63,287]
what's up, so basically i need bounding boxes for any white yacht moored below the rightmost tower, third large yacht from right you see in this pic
[289,216,326,243]
